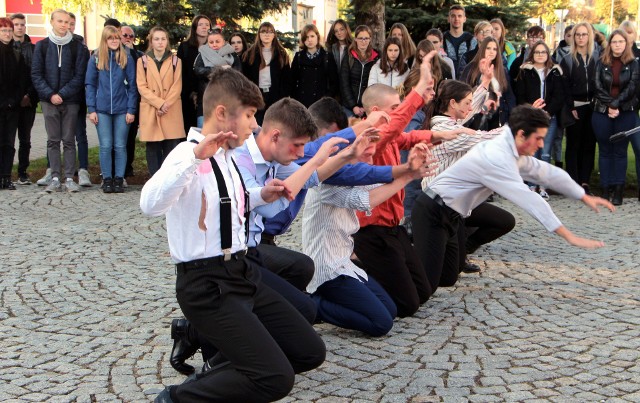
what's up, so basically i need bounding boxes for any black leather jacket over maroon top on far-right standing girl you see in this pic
[593,59,640,113]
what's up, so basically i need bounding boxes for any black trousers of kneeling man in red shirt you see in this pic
[353,225,433,317]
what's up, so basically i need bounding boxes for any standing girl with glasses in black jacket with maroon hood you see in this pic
[340,25,380,117]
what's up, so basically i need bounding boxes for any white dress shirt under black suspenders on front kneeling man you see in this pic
[140,128,265,263]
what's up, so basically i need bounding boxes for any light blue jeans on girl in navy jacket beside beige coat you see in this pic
[97,113,129,179]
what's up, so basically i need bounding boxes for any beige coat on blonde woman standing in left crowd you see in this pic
[136,53,186,141]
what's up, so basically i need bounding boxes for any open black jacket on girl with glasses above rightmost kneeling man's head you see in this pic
[514,63,564,116]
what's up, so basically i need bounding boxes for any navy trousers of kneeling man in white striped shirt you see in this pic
[311,275,397,336]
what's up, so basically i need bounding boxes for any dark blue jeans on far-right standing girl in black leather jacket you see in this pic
[591,111,636,189]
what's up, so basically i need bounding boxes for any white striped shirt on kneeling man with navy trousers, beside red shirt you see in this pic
[302,183,380,293]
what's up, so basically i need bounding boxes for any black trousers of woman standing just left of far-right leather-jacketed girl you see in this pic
[564,105,596,185]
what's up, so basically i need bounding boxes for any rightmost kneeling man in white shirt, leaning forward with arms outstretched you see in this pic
[411,105,615,291]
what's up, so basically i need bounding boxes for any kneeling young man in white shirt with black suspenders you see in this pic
[140,69,326,402]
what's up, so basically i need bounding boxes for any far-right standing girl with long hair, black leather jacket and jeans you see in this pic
[591,29,640,206]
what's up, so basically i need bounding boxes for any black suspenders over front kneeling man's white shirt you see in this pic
[191,140,251,260]
